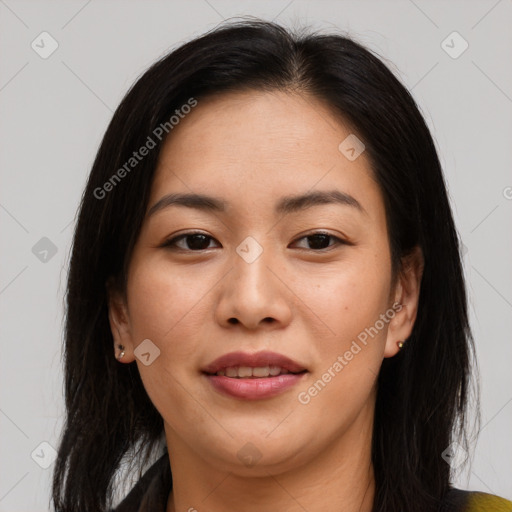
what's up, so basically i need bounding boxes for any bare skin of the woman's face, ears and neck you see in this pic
[109,91,423,512]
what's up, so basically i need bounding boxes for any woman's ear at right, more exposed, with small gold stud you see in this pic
[384,246,424,357]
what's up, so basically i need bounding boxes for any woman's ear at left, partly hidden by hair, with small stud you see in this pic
[106,278,135,363]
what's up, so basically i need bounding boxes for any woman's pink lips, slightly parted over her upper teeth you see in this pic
[203,351,306,400]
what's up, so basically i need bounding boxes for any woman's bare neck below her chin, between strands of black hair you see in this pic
[167,404,375,512]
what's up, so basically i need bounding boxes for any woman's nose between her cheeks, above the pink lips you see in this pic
[216,242,293,330]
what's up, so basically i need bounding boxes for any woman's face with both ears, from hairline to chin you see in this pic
[110,91,417,474]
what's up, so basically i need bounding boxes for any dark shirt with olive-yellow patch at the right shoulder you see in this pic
[110,450,512,512]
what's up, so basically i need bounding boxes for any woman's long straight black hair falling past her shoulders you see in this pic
[52,19,480,512]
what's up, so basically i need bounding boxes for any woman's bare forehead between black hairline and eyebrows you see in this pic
[152,91,380,220]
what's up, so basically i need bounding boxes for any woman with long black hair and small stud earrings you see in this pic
[52,21,512,512]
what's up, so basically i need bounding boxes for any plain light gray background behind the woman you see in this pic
[0,0,512,512]
